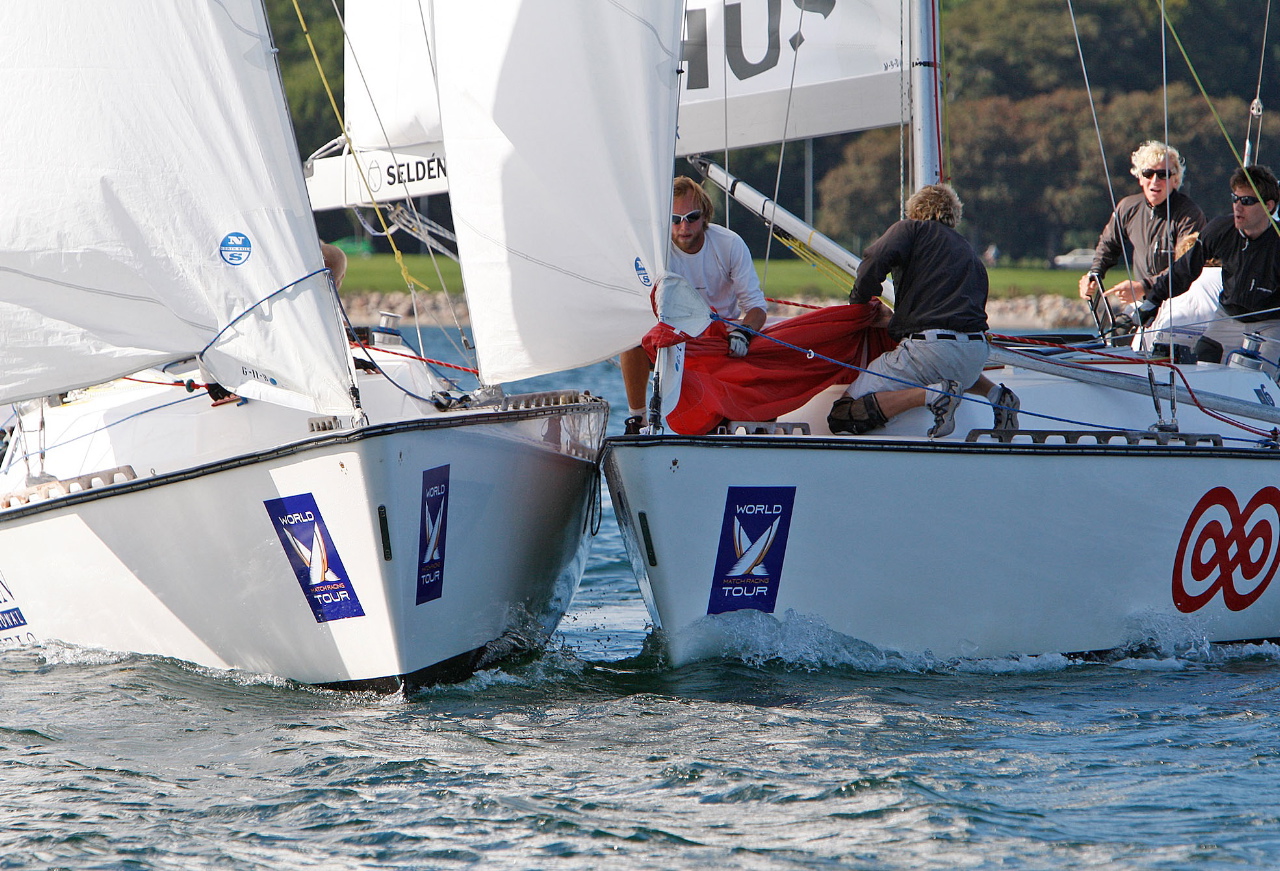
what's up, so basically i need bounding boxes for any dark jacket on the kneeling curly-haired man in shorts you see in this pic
[849,220,987,342]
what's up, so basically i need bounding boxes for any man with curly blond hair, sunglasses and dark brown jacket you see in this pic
[1080,140,1204,304]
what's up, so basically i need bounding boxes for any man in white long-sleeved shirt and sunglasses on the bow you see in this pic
[618,175,767,436]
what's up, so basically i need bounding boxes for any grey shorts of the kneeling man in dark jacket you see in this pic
[846,329,988,398]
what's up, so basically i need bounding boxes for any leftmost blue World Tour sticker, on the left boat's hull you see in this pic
[262,493,365,623]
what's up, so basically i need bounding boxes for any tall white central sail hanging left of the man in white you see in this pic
[434,0,681,382]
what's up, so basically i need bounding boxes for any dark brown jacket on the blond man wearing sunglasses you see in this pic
[1093,191,1204,284]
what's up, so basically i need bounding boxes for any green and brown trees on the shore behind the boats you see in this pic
[268,0,1280,259]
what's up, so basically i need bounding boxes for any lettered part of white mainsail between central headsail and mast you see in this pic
[676,0,920,155]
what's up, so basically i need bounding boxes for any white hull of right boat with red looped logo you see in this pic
[603,368,1280,665]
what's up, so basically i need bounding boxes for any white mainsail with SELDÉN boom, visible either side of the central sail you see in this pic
[316,0,916,209]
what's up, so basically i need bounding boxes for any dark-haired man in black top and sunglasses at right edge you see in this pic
[1139,167,1280,369]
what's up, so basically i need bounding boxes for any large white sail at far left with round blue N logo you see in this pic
[0,0,353,414]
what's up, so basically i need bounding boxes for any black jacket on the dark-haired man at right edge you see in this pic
[1147,215,1280,322]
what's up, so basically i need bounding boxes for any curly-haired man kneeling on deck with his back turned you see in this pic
[827,184,1018,438]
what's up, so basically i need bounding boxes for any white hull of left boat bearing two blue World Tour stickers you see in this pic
[0,381,607,688]
